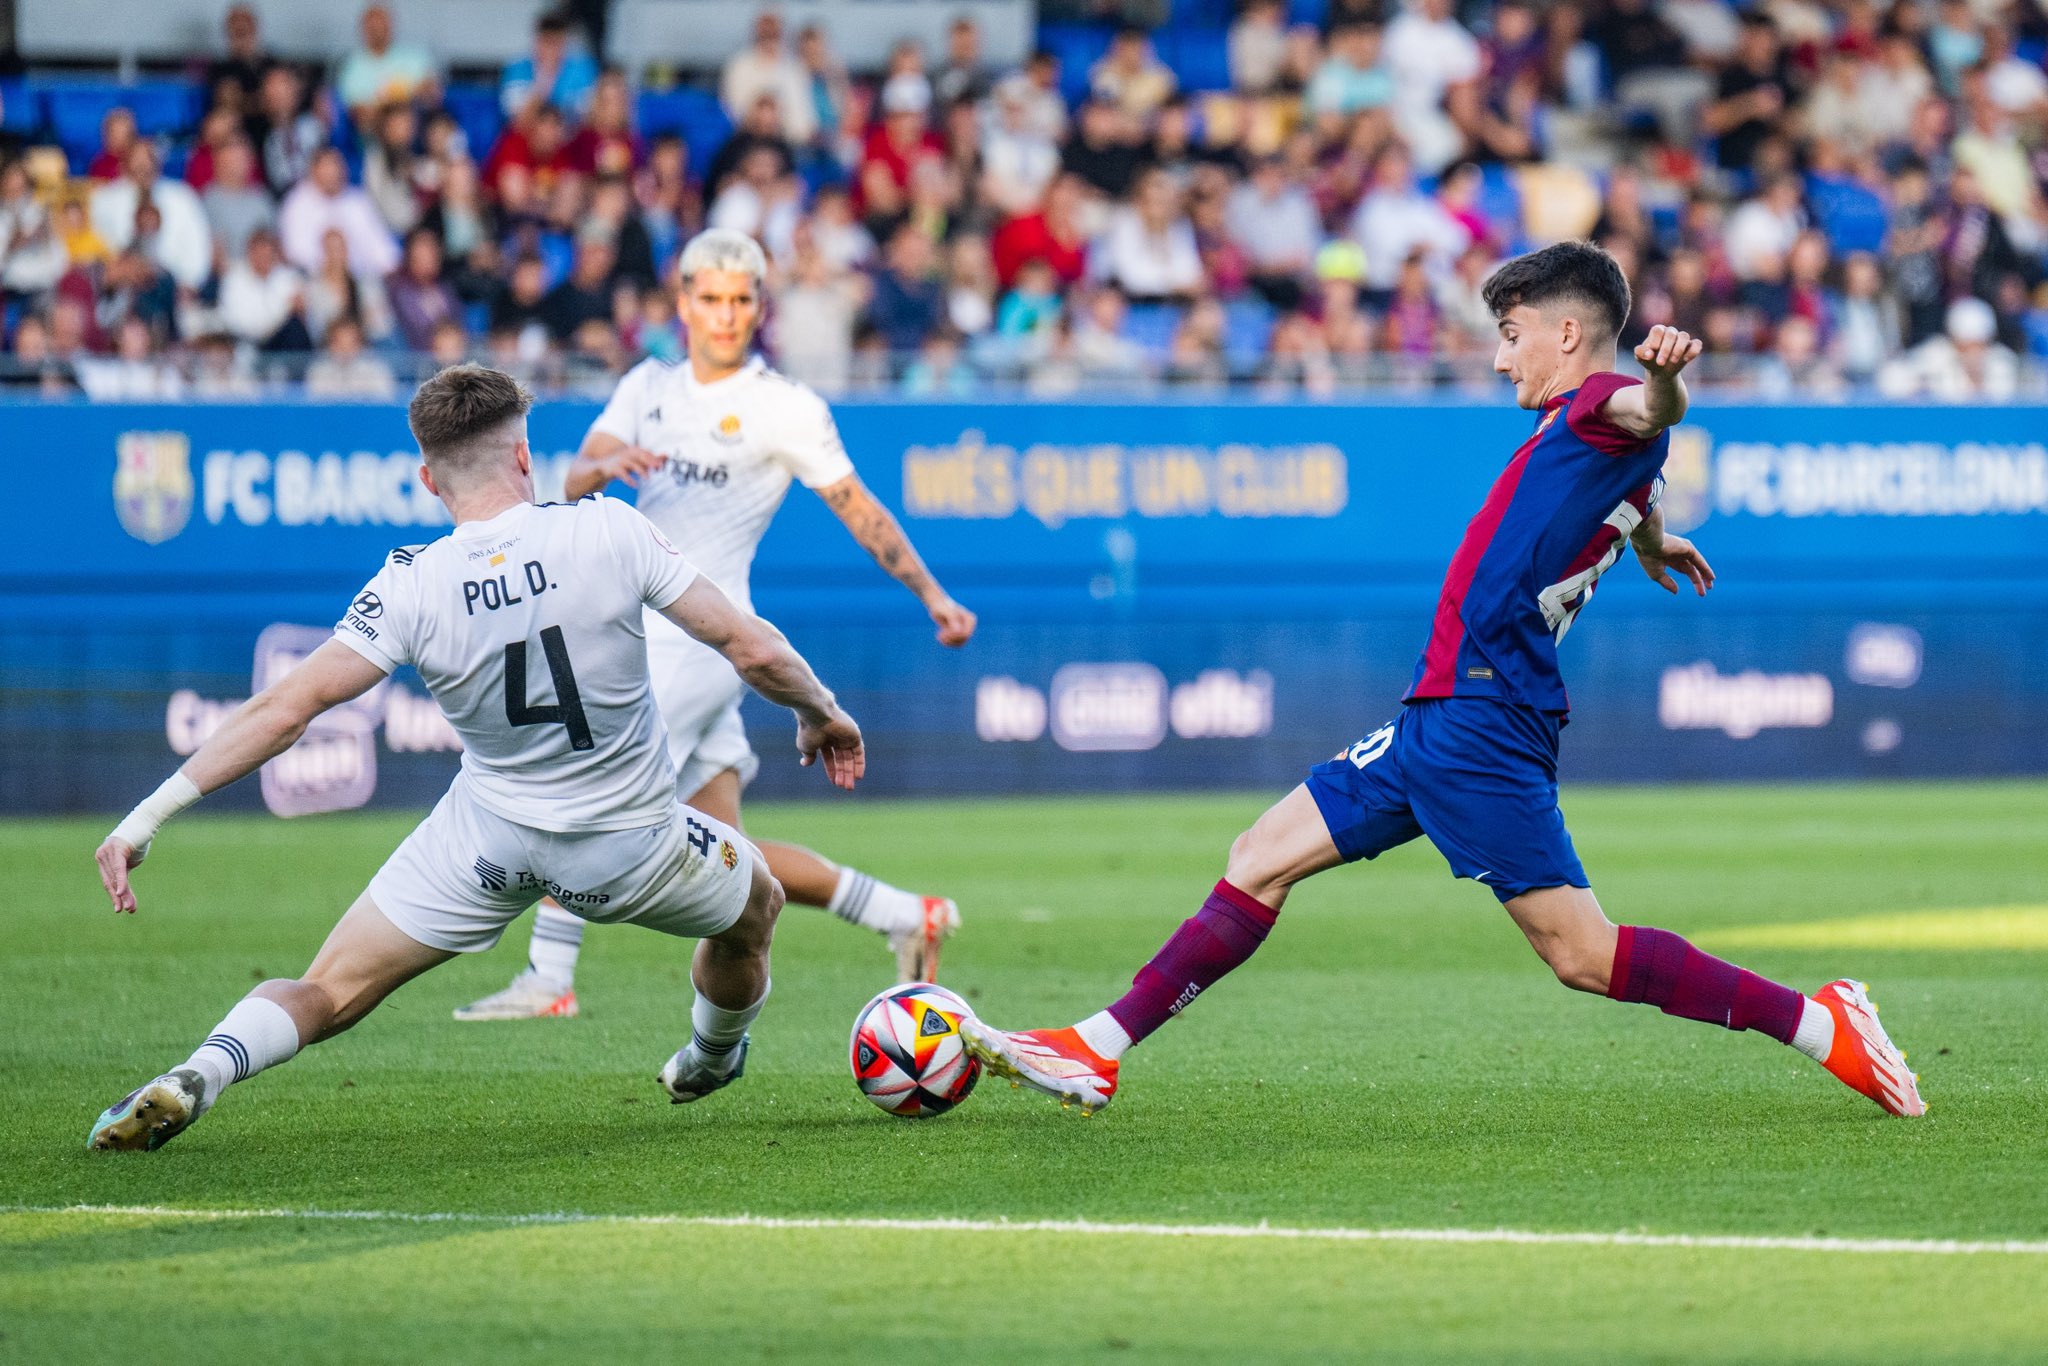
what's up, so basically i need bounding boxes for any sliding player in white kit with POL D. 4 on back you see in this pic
[88,365,866,1149]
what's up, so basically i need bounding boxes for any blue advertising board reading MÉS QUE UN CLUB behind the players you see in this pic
[0,399,2048,811]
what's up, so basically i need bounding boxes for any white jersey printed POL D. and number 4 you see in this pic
[334,496,696,831]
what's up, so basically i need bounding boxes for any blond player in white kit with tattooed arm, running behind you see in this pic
[455,227,975,1020]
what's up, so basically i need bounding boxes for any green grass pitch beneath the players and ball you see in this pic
[0,782,2048,1364]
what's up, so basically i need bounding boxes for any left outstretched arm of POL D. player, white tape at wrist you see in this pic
[94,641,385,911]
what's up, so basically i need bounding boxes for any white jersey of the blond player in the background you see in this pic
[590,356,854,610]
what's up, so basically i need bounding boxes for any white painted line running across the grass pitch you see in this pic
[12,1204,2048,1257]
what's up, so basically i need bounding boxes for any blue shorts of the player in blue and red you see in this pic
[1309,696,1589,901]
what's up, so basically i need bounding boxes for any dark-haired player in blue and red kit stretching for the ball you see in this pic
[961,242,1925,1116]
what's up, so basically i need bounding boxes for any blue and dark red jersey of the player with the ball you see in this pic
[1403,371,1671,713]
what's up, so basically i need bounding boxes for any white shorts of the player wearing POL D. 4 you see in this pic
[369,778,754,952]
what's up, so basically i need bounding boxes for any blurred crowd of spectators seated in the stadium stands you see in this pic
[0,0,2048,399]
